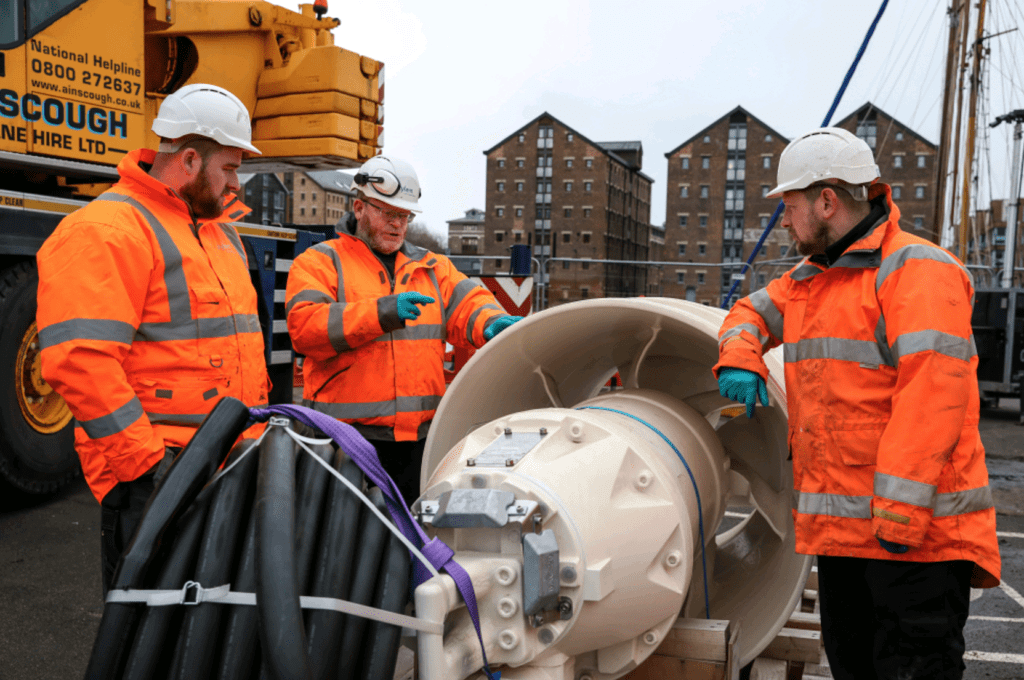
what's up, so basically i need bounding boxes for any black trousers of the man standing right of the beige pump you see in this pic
[818,555,973,680]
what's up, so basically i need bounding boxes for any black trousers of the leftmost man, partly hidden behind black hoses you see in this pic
[99,447,181,599]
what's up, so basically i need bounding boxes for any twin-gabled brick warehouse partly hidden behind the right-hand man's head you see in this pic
[662,102,938,306]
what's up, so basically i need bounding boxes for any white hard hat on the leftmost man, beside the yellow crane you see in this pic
[153,83,260,154]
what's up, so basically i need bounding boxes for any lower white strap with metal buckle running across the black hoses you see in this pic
[106,581,444,635]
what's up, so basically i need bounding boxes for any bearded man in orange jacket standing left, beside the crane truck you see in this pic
[37,85,269,593]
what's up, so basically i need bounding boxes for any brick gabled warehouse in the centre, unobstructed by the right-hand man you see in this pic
[481,113,653,308]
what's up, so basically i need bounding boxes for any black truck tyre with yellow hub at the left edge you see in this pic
[0,262,81,494]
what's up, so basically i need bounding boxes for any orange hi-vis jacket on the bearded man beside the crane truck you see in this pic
[36,150,268,501]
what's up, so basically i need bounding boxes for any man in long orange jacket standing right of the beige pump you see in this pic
[714,128,1000,680]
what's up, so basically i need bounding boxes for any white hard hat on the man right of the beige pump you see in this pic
[768,128,881,200]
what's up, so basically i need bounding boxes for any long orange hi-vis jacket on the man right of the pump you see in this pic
[715,183,1000,587]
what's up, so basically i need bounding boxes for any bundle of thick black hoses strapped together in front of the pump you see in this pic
[86,405,410,680]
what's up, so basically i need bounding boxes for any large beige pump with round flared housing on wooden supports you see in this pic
[416,298,810,680]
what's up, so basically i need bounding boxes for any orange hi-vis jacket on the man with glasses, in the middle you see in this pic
[286,233,505,441]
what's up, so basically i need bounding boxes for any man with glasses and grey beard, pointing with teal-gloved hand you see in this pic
[286,156,520,503]
